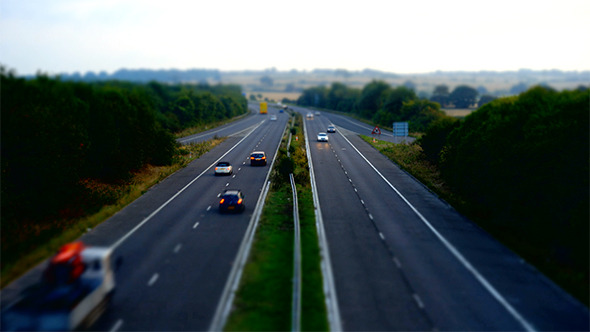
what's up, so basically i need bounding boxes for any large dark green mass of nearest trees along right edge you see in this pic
[419,86,590,285]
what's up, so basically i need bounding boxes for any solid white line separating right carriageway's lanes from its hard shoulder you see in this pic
[340,133,536,331]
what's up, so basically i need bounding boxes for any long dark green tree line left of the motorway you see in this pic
[0,67,247,223]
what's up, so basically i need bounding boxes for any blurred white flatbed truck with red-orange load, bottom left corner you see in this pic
[2,242,115,331]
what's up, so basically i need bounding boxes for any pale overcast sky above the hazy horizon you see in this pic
[0,0,590,75]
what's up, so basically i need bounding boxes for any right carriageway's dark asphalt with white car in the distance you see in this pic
[294,107,589,330]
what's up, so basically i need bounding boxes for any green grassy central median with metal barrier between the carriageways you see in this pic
[225,115,329,331]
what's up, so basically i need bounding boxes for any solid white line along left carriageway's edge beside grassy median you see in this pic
[208,116,287,331]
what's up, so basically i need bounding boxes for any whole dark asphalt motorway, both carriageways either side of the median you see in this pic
[2,103,590,331]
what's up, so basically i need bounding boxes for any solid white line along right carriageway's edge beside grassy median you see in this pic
[303,115,342,331]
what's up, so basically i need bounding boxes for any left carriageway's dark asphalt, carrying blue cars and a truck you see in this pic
[2,105,290,331]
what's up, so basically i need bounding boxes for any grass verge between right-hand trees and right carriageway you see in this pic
[361,135,590,306]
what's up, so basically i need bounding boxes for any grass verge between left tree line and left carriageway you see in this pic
[1,138,225,287]
